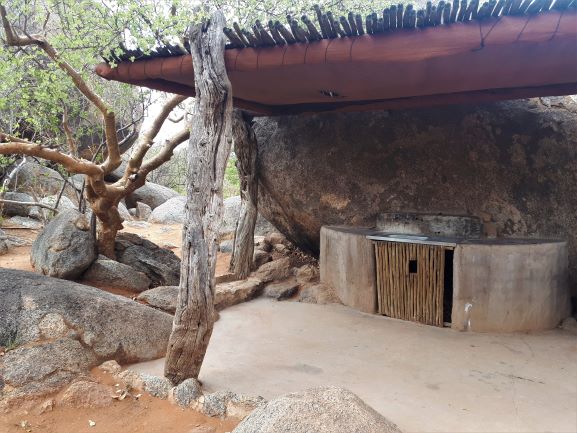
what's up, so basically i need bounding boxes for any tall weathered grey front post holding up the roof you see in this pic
[164,12,232,384]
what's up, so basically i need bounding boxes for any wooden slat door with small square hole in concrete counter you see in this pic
[374,241,445,327]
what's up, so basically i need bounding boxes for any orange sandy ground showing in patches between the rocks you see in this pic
[0,223,238,433]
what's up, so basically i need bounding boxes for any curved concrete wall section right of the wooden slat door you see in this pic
[451,242,569,332]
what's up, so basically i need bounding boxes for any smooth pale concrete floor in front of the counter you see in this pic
[134,299,577,432]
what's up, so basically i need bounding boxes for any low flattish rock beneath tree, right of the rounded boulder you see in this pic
[82,256,151,292]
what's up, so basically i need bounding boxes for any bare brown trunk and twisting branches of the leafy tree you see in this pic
[0,5,189,259]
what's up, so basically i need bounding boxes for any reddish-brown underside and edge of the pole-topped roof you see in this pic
[97,4,577,115]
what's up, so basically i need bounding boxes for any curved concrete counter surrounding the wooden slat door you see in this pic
[320,226,570,332]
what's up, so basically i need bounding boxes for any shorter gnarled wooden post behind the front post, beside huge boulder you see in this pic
[230,110,258,279]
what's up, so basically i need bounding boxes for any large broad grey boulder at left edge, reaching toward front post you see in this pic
[0,268,172,363]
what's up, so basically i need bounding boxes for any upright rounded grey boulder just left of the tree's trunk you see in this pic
[30,209,96,279]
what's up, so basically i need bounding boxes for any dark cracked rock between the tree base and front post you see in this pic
[115,233,180,287]
